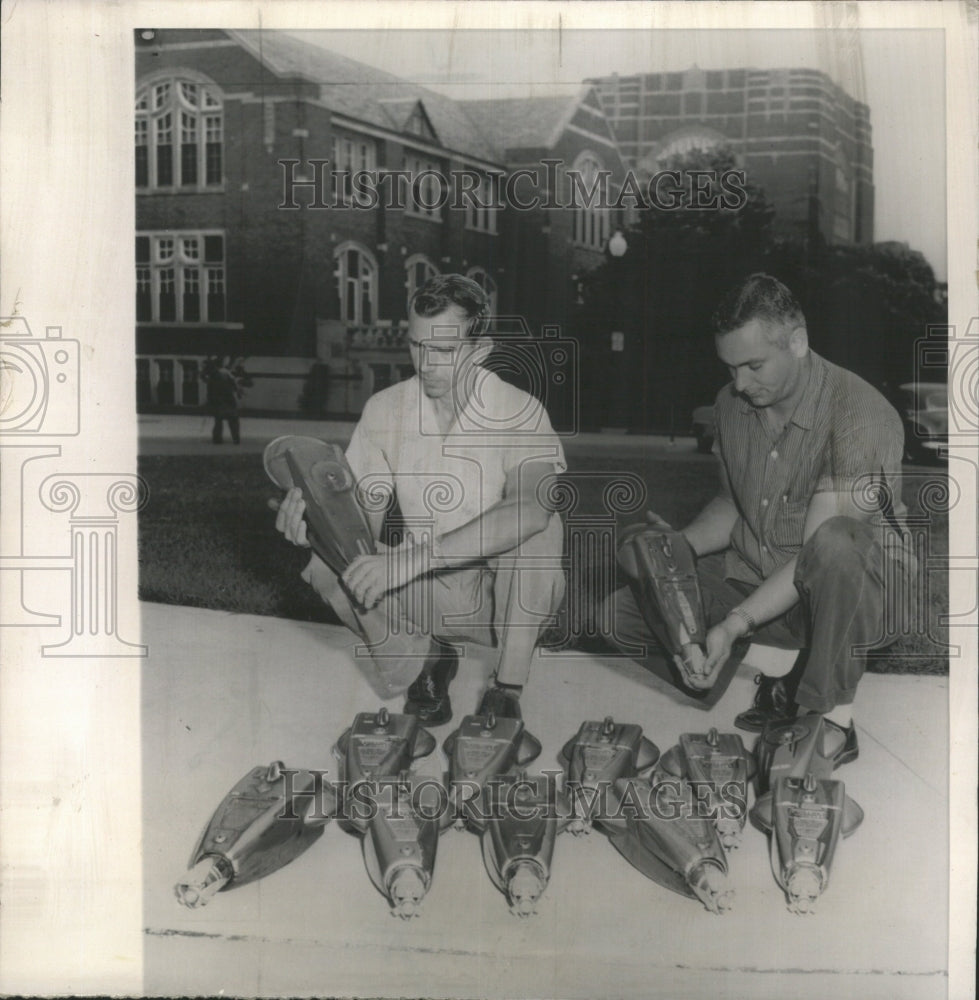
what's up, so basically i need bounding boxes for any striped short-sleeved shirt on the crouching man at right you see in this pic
[714,351,906,584]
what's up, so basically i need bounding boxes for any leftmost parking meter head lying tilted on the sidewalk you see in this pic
[174,761,336,909]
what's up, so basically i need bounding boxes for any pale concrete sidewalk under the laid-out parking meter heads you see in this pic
[142,604,948,1000]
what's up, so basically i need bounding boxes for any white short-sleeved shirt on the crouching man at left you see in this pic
[347,369,567,551]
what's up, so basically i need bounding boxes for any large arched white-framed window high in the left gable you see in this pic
[136,76,224,191]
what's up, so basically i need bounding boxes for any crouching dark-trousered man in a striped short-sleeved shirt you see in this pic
[606,274,914,764]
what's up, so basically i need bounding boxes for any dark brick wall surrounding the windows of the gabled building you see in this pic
[136,31,624,422]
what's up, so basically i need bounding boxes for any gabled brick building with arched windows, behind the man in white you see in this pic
[135,30,625,423]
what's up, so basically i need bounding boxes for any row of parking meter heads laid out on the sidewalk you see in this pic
[175,708,863,918]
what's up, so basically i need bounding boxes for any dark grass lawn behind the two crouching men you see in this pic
[139,454,948,674]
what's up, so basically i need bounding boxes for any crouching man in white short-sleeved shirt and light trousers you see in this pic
[276,274,566,725]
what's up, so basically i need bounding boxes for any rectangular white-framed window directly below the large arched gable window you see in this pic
[136,230,228,324]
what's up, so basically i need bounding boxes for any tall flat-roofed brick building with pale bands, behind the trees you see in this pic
[590,66,874,243]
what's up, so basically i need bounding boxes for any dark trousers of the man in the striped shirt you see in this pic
[603,517,914,712]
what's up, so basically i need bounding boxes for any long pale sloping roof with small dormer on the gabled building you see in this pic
[227,31,503,164]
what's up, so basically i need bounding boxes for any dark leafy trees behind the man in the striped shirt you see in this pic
[582,148,946,433]
